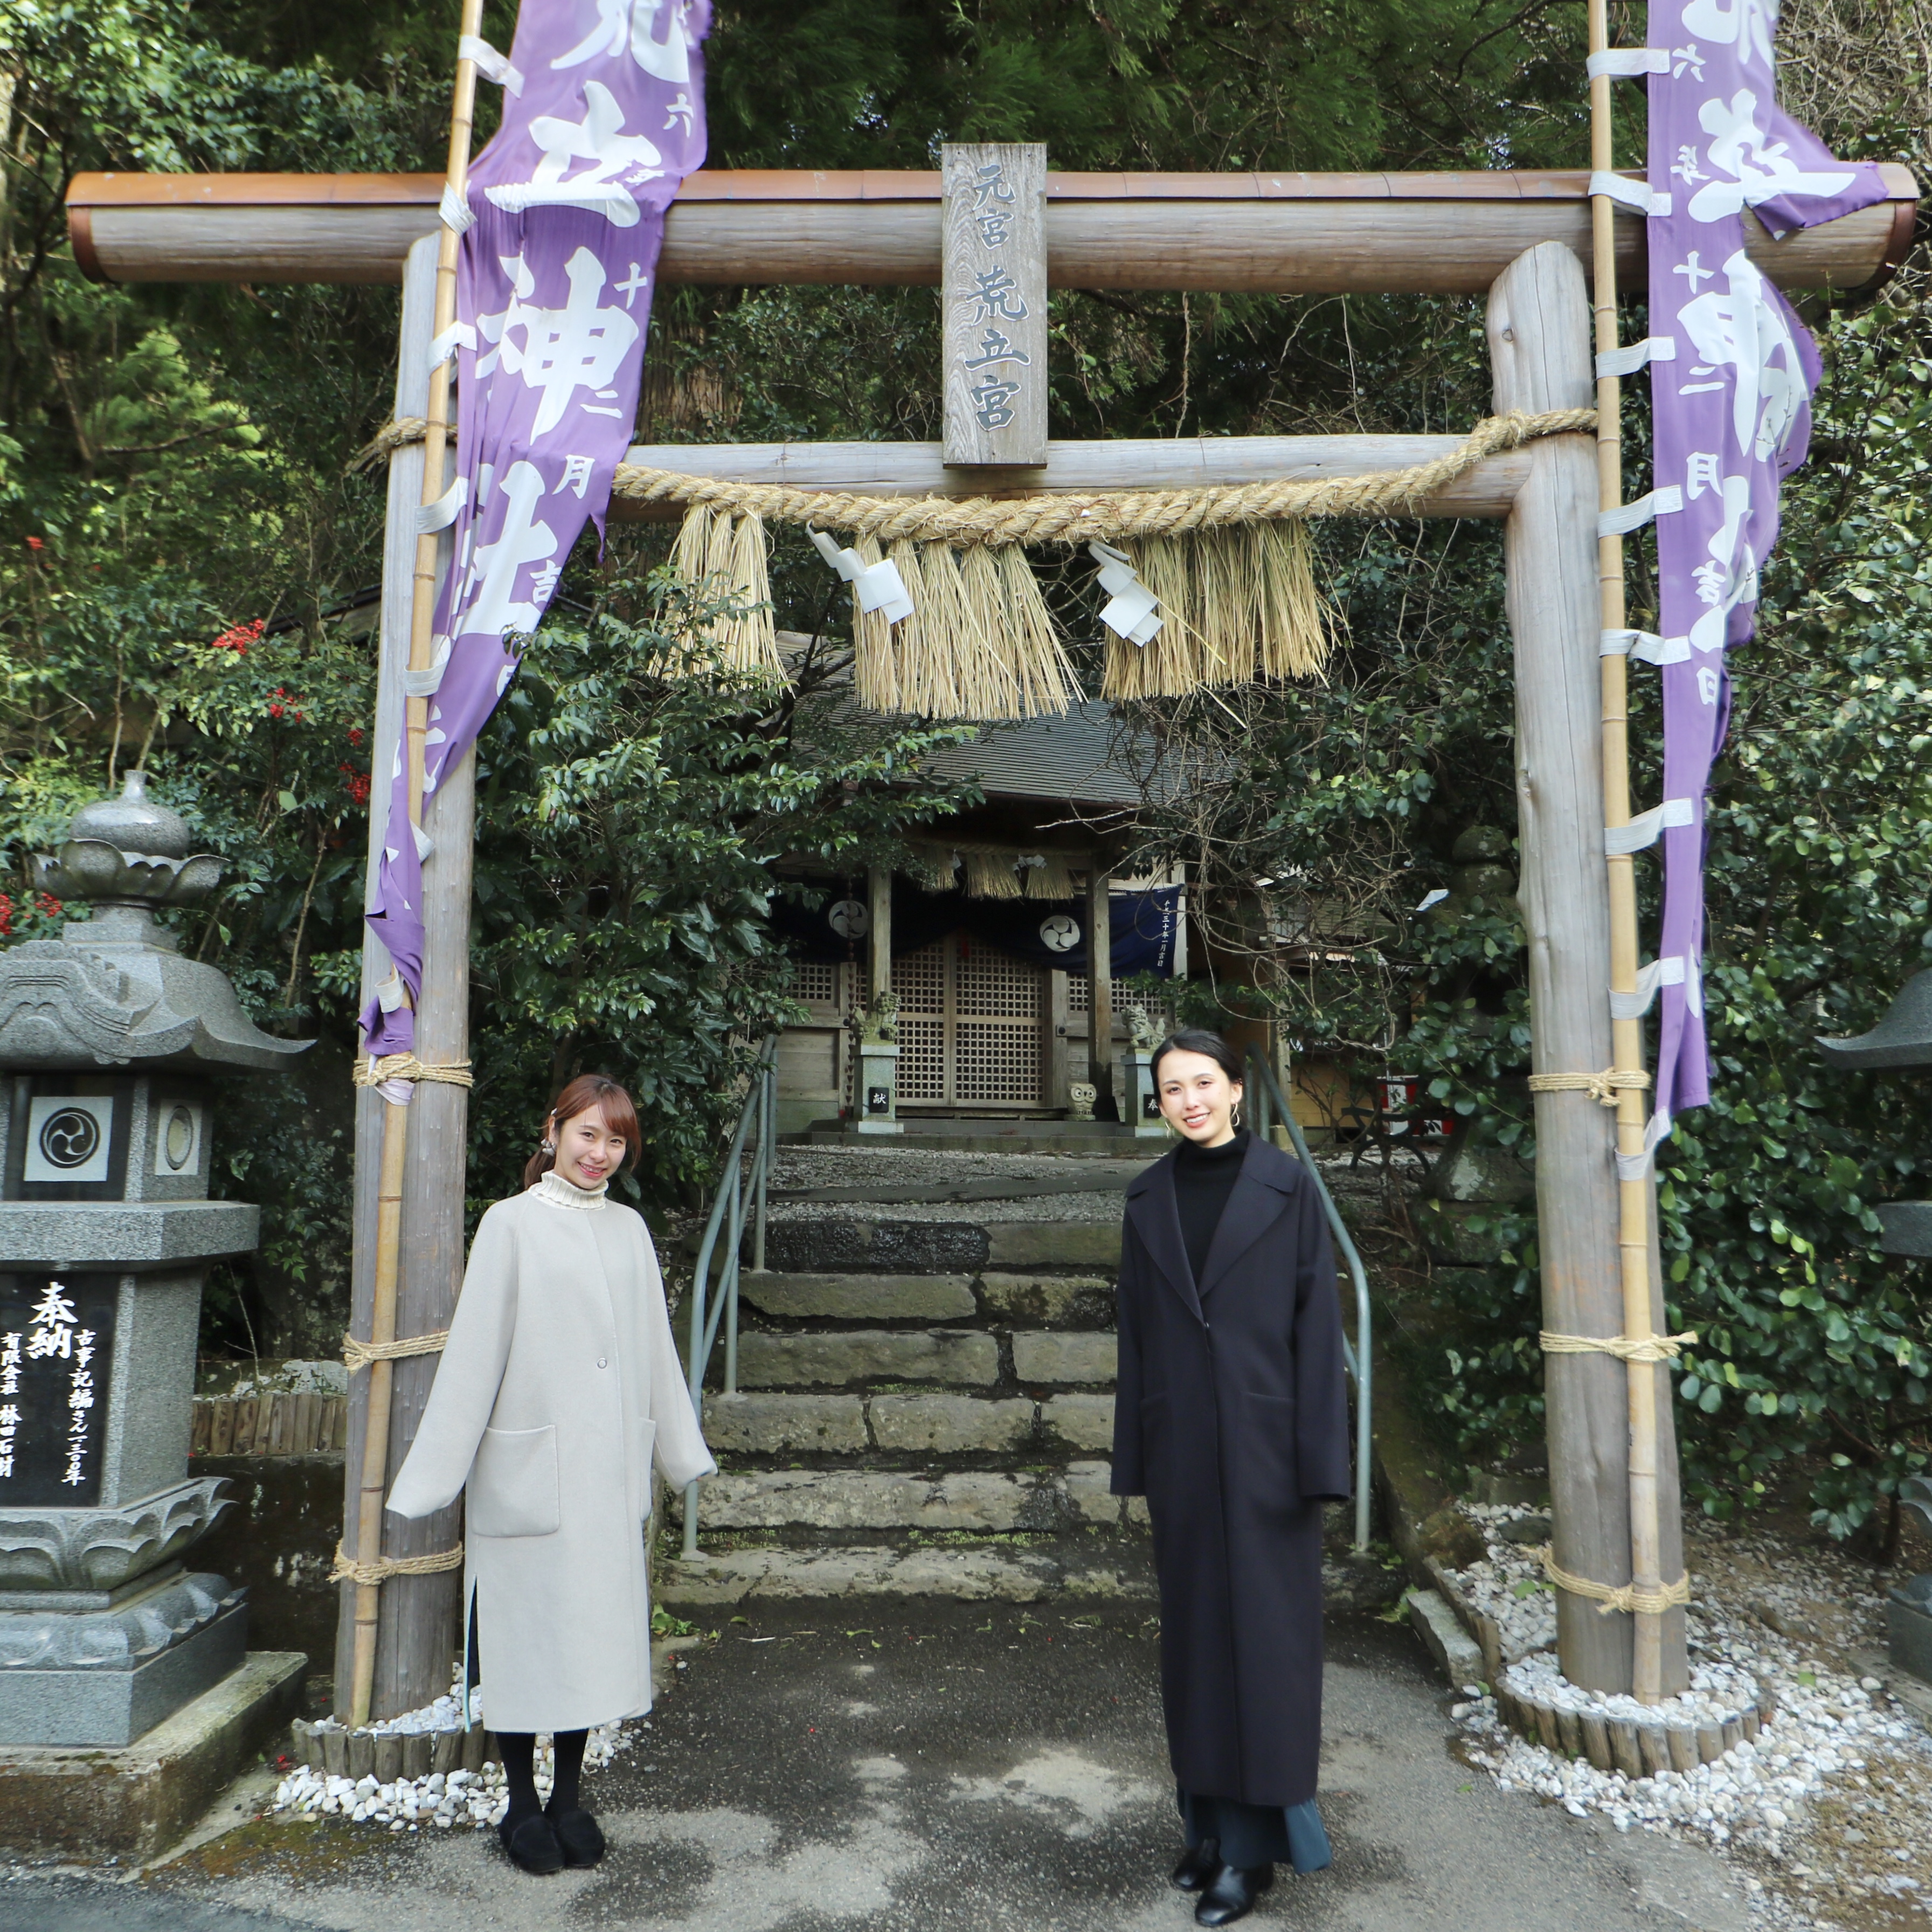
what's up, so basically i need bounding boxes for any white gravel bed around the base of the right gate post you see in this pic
[1451,1503,1932,1926]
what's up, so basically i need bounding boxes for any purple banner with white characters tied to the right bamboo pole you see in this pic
[1630,0,1886,1147]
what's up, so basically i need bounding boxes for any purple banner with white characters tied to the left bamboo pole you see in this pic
[361,0,711,1055]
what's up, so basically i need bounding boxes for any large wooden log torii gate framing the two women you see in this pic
[67,150,1916,1715]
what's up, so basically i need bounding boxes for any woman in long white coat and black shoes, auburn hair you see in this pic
[389,1074,717,1872]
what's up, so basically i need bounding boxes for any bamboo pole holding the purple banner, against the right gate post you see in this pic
[1588,0,1681,1704]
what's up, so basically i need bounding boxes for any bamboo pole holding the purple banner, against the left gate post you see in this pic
[350,0,483,1725]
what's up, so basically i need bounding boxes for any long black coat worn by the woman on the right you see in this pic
[1113,1138,1348,1804]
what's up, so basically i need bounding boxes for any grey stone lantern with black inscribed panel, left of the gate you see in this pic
[0,771,307,1748]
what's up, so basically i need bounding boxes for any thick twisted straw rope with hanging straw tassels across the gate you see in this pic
[357,410,1596,719]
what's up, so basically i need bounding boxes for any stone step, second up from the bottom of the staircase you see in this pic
[670,1463,1147,1532]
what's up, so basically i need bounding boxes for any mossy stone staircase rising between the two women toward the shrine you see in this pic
[657,1149,1152,1608]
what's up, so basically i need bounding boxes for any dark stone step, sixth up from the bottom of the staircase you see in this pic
[753,1213,1120,1275]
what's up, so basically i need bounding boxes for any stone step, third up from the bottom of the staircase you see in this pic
[705,1393,1113,1457]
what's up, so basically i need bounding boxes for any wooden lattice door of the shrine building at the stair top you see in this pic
[892,933,1045,1107]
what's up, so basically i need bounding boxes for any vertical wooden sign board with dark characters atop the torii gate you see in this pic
[939,143,1047,468]
